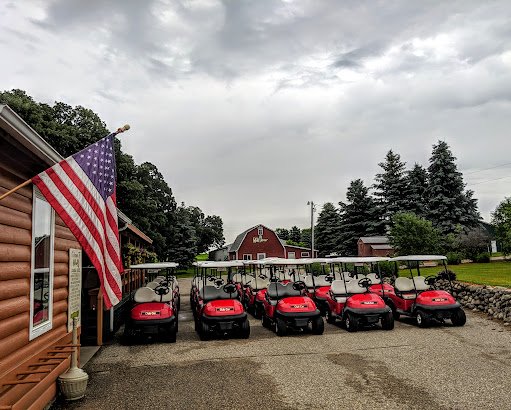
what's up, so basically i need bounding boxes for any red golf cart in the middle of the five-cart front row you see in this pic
[261,259,324,336]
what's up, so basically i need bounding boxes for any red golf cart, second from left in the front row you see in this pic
[192,261,250,340]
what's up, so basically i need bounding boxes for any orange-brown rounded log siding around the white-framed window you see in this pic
[0,134,80,408]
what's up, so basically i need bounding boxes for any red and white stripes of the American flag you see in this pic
[32,157,122,309]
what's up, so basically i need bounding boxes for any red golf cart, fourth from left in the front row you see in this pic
[326,257,394,332]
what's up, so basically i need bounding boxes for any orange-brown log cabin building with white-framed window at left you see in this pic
[0,104,151,410]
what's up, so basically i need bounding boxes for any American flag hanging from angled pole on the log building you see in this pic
[32,133,123,309]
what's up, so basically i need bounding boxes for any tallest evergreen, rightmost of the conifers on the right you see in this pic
[426,141,481,234]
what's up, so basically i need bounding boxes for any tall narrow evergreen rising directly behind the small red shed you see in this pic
[373,150,407,224]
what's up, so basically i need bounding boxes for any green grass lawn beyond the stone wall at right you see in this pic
[399,262,511,288]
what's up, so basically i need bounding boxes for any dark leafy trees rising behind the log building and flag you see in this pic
[0,90,225,266]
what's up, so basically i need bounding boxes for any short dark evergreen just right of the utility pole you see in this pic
[315,202,341,256]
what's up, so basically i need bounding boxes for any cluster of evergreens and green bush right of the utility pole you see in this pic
[315,141,488,256]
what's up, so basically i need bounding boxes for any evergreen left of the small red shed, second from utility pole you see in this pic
[339,179,385,256]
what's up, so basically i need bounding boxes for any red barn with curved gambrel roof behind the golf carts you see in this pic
[229,225,318,260]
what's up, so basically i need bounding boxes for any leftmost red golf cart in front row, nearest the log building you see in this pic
[124,262,179,343]
